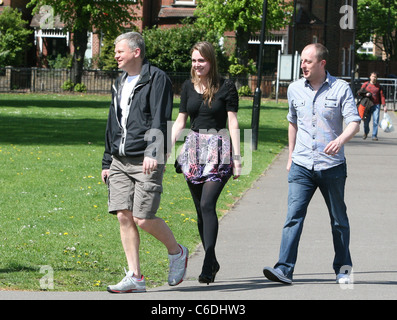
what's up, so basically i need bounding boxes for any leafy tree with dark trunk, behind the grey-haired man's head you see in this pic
[30,0,140,83]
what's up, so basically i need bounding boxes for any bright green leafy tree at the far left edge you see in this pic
[0,7,32,67]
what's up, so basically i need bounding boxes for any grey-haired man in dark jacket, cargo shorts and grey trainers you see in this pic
[102,32,188,293]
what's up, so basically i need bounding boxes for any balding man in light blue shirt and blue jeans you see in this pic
[263,43,361,284]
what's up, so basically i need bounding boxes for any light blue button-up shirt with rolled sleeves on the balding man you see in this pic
[287,72,361,171]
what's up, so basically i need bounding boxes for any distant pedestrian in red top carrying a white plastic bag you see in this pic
[357,72,387,141]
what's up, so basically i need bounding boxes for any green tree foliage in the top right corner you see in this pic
[356,0,397,61]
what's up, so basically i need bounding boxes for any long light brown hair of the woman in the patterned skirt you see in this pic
[190,41,220,106]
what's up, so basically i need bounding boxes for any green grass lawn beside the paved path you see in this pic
[0,94,287,291]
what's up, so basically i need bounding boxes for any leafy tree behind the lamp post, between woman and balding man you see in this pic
[195,0,292,65]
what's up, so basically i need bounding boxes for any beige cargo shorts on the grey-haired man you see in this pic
[107,156,164,219]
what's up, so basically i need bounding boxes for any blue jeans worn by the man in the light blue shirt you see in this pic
[275,163,352,279]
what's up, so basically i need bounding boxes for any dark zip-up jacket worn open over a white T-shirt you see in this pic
[102,60,173,169]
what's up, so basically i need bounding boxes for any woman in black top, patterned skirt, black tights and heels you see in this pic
[172,42,241,284]
